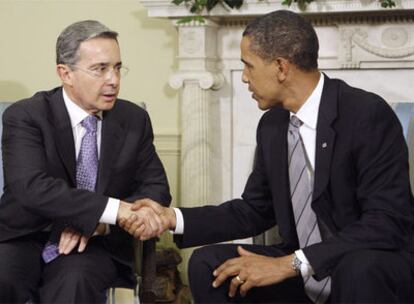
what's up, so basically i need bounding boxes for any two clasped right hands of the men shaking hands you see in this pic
[117,198,176,241]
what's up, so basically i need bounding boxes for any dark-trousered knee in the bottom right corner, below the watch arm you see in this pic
[331,250,413,303]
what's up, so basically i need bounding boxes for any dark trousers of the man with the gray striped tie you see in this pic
[189,244,414,303]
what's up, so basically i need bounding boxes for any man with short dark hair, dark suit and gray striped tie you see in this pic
[122,11,414,303]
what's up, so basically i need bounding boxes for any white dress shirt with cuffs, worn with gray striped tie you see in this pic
[173,74,324,278]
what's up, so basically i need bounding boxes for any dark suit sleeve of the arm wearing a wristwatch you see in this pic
[303,97,413,279]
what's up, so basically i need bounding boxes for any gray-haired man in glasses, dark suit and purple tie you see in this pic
[0,21,171,303]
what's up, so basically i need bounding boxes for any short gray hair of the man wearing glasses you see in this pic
[56,20,118,67]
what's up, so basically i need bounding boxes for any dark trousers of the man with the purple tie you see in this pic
[0,233,118,303]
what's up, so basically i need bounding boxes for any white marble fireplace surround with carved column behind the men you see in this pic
[139,0,414,216]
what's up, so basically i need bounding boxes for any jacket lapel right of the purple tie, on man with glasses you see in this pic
[96,109,126,194]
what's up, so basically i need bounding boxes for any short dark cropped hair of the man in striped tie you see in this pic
[243,10,319,70]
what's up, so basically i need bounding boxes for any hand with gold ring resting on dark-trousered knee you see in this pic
[213,246,297,297]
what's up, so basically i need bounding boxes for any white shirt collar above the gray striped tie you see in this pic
[290,73,325,130]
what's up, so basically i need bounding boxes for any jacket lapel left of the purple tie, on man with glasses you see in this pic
[48,88,76,185]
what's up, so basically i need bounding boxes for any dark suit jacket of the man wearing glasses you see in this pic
[0,88,171,278]
